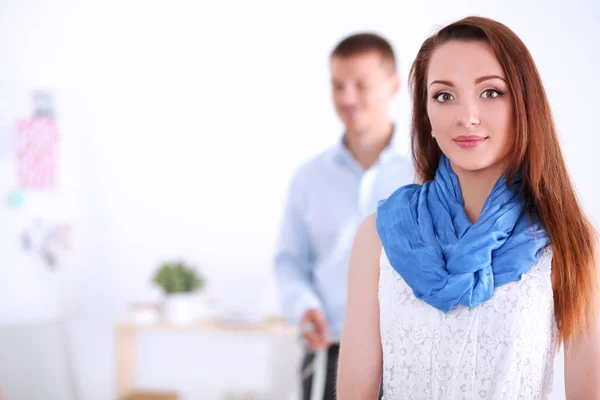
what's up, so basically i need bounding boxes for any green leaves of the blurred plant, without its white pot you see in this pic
[152,261,206,295]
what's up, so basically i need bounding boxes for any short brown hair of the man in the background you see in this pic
[331,33,396,71]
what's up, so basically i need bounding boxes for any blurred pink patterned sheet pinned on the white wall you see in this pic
[16,117,59,190]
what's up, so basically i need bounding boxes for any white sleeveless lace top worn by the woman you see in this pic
[379,248,557,400]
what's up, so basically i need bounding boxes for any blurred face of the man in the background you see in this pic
[331,52,400,133]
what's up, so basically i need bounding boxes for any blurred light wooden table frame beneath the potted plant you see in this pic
[114,318,298,400]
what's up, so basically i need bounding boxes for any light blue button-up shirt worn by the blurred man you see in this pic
[275,134,414,337]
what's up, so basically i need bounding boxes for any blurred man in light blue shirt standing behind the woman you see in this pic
[275,33,413,400]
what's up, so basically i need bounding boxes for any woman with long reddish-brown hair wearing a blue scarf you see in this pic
[337,17,600,400]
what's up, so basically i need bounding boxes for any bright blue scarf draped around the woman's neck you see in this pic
[377,155,548,313]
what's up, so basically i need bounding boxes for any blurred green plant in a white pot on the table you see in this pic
[152,261,206,324]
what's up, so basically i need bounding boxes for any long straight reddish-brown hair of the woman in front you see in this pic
[409,17,598,342]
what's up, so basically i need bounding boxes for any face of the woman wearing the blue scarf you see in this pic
[426,40,515,173]
